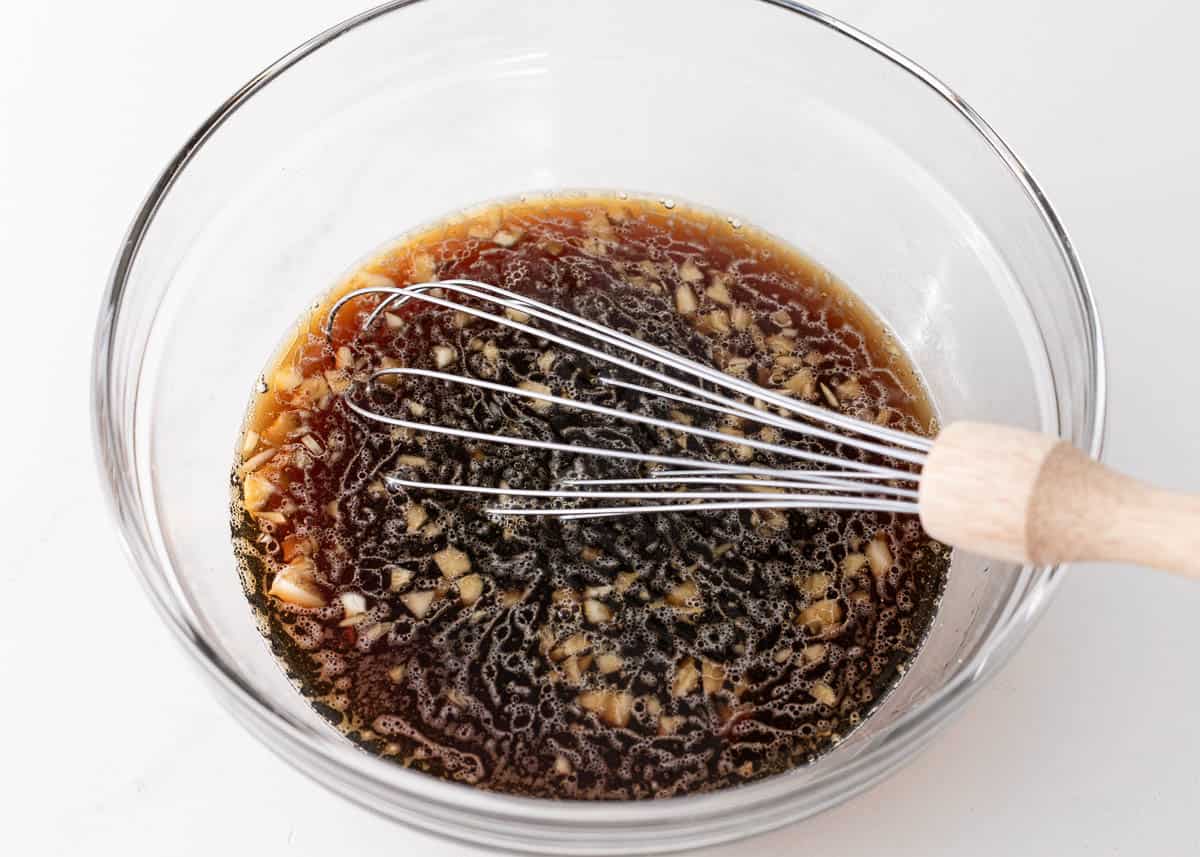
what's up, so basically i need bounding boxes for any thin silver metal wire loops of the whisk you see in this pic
[326,280,931,519]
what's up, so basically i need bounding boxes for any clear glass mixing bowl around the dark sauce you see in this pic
[94,0,1104,853]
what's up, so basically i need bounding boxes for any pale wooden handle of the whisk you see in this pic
[918,422,1200,577]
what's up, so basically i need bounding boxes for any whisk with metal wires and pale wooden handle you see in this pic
[326,280,1200,576]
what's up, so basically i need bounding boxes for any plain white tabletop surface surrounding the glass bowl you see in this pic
[0,0,1200,857]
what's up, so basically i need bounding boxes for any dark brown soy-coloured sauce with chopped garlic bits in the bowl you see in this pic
[233,196,949,798]
